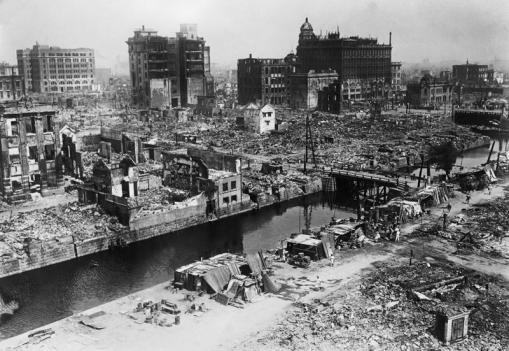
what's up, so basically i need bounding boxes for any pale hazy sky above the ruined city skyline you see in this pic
[0,0,509,71]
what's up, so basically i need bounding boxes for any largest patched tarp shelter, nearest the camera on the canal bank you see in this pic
[174,253,251,293]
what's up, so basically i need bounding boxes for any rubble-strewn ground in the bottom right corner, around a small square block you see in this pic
[257,263,509,350]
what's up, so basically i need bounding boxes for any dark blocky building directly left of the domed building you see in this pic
[237,54,295,105]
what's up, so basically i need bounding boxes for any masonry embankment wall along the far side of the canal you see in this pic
[0,180,322,278]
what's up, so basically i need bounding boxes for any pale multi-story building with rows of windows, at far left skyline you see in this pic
[17,43,95,93]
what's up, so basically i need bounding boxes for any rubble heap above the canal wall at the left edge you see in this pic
[0,202,125,257]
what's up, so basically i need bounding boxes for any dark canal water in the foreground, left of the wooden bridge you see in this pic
[0,194,353,338]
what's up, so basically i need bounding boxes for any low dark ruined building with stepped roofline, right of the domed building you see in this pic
[406,75,453,108]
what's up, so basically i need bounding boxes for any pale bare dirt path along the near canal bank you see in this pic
[0,250,391,351]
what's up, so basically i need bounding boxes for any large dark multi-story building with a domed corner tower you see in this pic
[297,18,392,84]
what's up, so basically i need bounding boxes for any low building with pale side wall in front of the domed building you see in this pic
[288,70,338,109]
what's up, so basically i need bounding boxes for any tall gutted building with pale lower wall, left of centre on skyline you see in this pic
[126,24,214,108]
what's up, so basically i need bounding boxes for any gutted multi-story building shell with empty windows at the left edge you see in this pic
[0,108,63,203]
